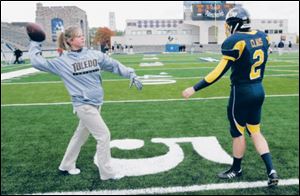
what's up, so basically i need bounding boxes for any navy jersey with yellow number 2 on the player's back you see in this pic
[222,31,269,85]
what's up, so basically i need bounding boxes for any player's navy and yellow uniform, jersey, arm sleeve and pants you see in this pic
[194,31,270,137]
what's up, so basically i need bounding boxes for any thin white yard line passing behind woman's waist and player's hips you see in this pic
[1,94,299,107]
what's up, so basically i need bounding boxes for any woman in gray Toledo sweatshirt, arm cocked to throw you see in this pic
[29,26,142,180]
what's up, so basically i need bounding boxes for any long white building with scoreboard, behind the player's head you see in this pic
[111,1,296,51]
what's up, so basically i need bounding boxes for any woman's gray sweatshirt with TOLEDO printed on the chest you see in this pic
[29,41,135,107]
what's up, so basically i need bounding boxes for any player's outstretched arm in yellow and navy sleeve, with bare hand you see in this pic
[182,56,233,99]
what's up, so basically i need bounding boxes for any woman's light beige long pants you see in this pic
[59,105,115,179]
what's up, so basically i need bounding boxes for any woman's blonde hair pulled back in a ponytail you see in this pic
[57,26,81,50]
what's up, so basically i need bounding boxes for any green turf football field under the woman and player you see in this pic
[1,53,299,195]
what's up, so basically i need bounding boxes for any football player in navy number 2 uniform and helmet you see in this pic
[182,7,278,186]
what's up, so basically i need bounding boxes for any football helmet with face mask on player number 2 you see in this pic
[225,7,251,35]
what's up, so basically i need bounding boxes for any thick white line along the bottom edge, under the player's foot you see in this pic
[29,178,299,195]
